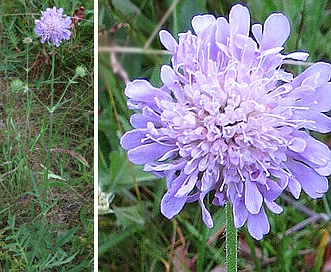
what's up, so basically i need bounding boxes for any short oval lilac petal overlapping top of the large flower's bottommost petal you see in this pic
[245,179,263,214]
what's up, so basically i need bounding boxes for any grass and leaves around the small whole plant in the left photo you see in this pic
[0,0,94,271]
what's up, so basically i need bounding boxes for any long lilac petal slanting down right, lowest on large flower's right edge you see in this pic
[286,160,329,198]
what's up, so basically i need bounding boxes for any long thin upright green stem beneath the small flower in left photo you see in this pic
[44,44,55,201]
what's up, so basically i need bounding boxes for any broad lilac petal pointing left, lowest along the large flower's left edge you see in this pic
[128,143,176,164]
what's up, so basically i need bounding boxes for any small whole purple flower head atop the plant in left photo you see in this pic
[34,7,71,47]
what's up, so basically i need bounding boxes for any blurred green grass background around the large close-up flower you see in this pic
[98,0,331,272]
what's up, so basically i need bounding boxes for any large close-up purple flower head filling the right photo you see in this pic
[121,4,331,240]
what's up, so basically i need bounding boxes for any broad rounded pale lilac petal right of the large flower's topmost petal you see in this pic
[260,13,290,51]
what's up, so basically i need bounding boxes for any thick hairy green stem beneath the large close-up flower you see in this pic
[226,203,237,272]
